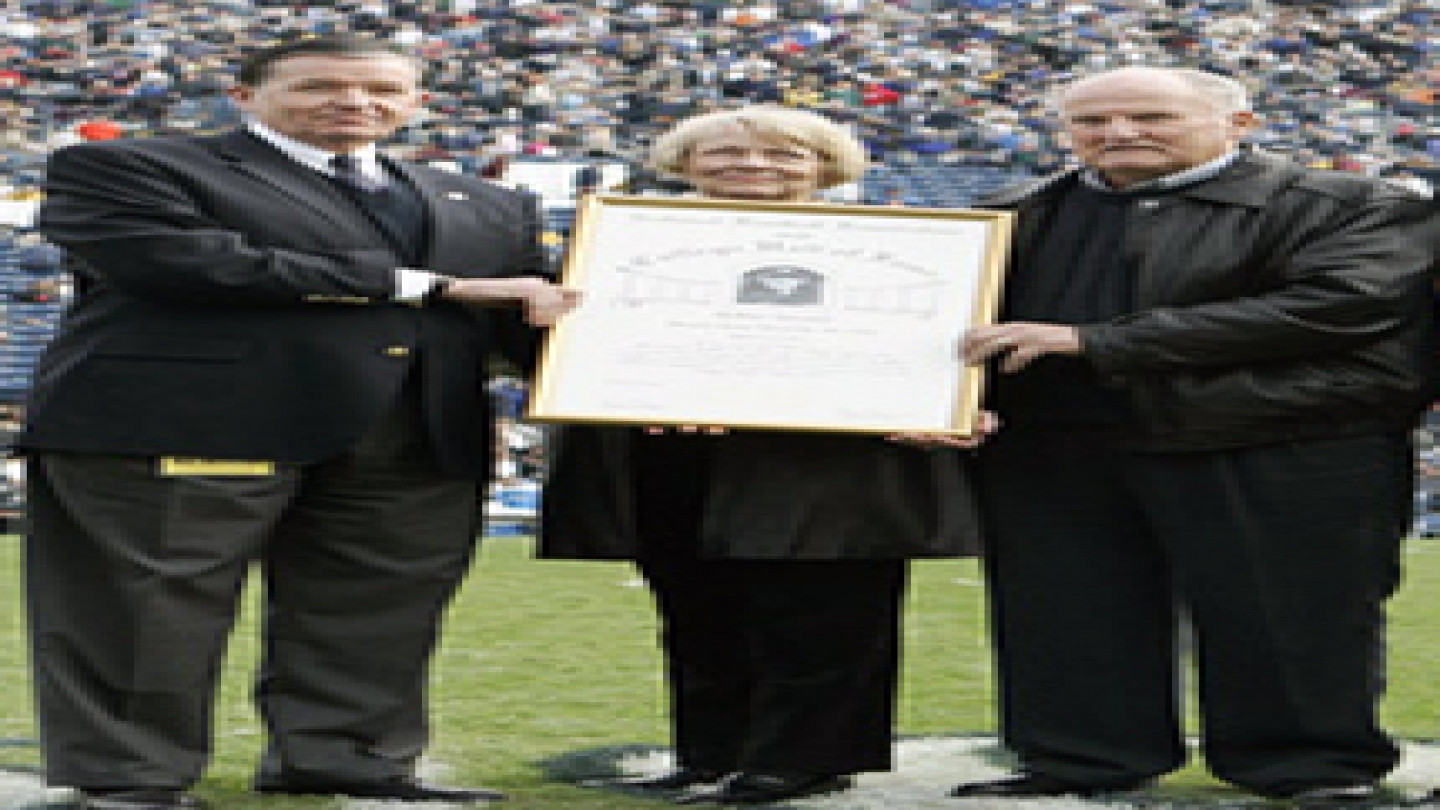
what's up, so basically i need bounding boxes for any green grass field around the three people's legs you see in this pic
[0,538,1440,810]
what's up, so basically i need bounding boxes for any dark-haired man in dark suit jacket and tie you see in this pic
[19,39,575,810]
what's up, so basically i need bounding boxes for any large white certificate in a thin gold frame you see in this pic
[528,195,1012,434]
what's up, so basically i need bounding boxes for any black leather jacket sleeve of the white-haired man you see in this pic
[1080,183,1431,375]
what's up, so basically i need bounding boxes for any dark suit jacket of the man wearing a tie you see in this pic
[19,131,543,474]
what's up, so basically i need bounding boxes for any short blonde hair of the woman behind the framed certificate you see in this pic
[649,104,868,189]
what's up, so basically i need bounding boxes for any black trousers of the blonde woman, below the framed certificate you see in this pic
[636,437,906,774]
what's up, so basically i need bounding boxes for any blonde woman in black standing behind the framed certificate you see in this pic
[541,105,976,804]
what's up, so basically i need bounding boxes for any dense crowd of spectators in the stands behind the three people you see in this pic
[0,0,1440,193]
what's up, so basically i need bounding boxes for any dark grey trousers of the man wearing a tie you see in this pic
[26,380,477,788]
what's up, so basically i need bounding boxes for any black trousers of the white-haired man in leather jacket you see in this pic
[979,428,1410,794]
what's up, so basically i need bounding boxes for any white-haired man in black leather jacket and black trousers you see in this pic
[953,68,1430,806]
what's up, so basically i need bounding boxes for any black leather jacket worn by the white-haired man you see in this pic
[979,151,1434,451]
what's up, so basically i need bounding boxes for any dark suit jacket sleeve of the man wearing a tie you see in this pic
[39,144,400,306]
